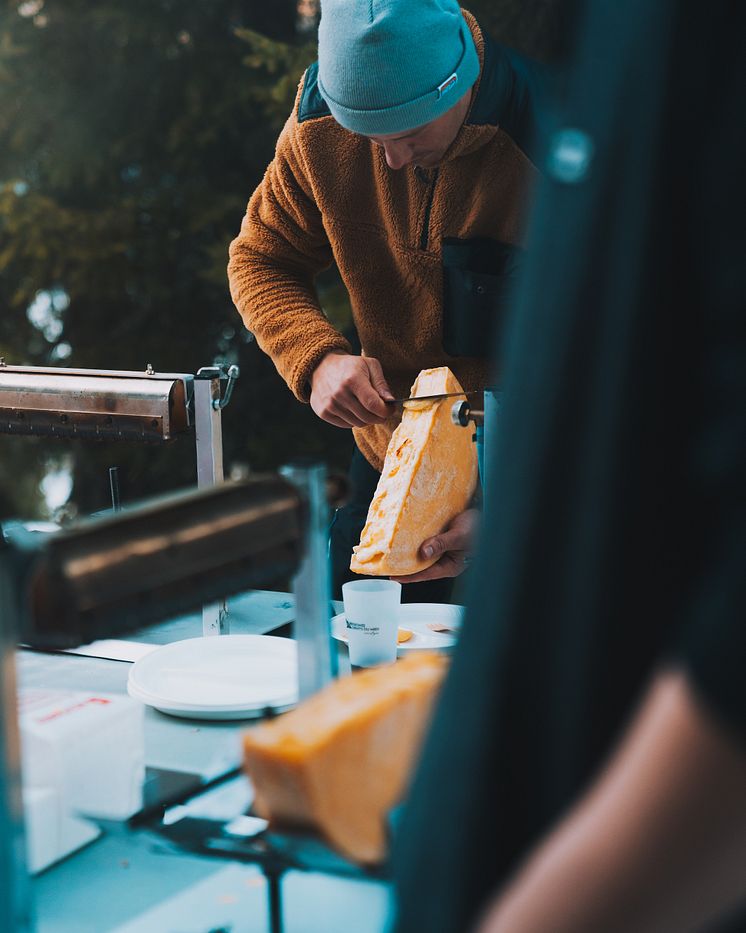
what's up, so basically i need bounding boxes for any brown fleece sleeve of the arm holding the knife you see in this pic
[228,107,352,402]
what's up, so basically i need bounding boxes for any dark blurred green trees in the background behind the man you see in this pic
[0,0,561,518]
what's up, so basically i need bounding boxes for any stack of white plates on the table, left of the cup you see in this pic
[127,635,298,719]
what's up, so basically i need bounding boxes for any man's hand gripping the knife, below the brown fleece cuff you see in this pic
[311,350,394,428]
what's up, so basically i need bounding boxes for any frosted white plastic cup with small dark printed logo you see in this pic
[342,580,401,667]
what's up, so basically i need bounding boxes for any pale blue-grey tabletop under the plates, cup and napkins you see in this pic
[18,591,389,933]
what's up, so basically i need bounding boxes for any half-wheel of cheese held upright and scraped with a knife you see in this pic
[350,366,477,577]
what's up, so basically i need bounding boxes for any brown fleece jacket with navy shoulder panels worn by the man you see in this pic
[228,12,536,470]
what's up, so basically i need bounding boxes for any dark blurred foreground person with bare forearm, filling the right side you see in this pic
[395,0,746,933]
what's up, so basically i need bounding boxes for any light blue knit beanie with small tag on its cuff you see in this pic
[318,0,479,136]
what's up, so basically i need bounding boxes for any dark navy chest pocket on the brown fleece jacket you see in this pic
[443,237,523,359]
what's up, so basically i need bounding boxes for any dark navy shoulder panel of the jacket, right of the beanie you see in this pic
[468,25,552,162]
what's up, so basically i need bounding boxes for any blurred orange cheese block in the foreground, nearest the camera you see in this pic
[243,652,447,864]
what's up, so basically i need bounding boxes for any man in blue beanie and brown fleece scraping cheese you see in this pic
[228,0,536,601]
